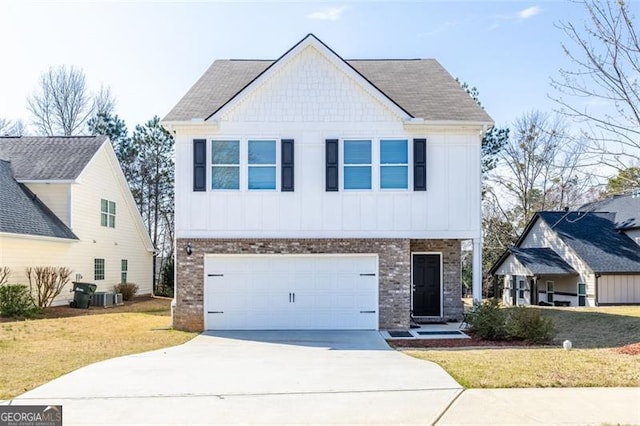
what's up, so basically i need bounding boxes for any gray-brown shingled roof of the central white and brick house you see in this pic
[163,35,493,123]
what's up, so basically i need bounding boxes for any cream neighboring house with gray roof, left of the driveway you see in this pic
[0,136,154,304]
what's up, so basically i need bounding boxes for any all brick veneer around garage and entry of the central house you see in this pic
[173,239,462,331]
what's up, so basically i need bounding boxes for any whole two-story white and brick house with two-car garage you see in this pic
[163,34,492,330]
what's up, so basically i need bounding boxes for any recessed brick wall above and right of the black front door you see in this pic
[410,240,463,320]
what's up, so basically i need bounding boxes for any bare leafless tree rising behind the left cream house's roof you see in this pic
[27,65,114,136]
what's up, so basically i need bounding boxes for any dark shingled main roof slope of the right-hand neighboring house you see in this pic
[540,212,640,273]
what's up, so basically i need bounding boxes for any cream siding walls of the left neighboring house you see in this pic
[0,144,153,305]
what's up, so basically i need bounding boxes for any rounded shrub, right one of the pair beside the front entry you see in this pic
[505,306,555,343]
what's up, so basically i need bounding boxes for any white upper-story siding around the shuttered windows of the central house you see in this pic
[172,47,482,239]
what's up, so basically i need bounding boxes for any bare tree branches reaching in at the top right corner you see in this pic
[552,0,640,170]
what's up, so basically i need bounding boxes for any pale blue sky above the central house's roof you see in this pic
[0,0,585,130]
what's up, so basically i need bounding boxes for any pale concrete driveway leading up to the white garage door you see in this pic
[12,331,462,425]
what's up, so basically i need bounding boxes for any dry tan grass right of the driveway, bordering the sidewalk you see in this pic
[405,348,640,388]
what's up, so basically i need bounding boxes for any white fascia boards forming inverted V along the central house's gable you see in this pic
[207,34,411,122]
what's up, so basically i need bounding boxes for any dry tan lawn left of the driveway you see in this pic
[0,299,195,399]
